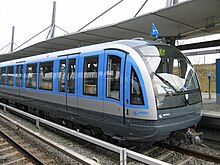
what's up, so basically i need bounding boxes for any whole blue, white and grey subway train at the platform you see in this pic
[0,39,202,142]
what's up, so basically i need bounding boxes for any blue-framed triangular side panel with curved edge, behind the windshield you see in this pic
[124,57,150,122]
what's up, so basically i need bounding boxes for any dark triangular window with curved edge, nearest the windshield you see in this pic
[130,67,144,105]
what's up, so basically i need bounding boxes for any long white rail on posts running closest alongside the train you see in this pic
[0,103,169,165]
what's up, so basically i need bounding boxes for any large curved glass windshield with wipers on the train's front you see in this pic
[137,45,201,108]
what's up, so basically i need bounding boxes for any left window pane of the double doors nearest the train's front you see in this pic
[58,60,66,92]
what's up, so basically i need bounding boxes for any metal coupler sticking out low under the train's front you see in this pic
[185,128,203,145]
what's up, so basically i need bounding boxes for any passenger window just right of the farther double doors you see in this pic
[26,64,37,88]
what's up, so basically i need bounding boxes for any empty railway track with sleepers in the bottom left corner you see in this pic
[0,113,98,165]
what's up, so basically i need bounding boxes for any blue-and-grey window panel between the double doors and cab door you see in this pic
[78,51,104,121]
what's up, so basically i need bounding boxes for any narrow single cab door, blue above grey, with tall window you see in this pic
[104,50,126,124]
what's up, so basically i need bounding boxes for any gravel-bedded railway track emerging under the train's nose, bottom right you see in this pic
[134,142,220,165]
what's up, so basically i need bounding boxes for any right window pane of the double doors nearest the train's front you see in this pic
[67,59,76,93]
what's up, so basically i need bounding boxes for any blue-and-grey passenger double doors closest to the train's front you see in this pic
[58,55,78,115]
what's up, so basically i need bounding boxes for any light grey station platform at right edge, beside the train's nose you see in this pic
[202,93,220,119]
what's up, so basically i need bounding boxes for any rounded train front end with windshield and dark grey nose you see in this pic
[129,43,202,141]
